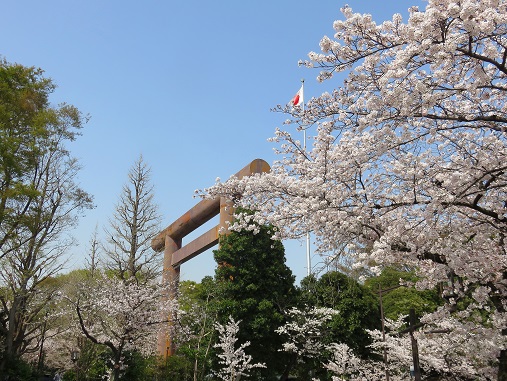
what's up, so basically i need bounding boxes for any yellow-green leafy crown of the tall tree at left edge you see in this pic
[0,59,88,258]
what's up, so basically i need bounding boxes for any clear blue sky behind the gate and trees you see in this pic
[0,0,425,281]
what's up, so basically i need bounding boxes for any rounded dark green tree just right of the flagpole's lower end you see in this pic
[300,271,380,356]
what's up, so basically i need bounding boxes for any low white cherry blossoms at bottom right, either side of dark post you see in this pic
[324,316,498,381]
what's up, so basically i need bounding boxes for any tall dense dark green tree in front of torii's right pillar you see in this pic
[214,221,296,380]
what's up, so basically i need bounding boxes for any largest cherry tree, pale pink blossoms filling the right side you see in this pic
[205,0,507,380]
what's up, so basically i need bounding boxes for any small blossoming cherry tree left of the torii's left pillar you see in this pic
[67,275,177,380]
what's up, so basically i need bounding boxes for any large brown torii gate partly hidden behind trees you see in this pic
[151,159,270,356]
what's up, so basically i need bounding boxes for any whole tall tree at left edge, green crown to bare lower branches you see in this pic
[0,60,92,374]
